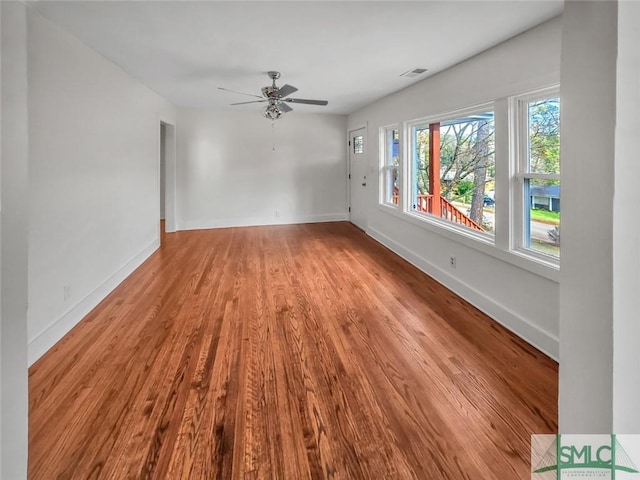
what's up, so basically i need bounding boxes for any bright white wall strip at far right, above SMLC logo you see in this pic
[612,2,640,433]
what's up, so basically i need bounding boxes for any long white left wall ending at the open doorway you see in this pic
[28,11,175,362]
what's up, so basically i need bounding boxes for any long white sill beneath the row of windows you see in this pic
[378,204,560,283]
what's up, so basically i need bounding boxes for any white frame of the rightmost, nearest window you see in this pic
[509,85,562,267]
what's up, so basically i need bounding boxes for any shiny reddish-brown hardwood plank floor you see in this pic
[29,223,558,480]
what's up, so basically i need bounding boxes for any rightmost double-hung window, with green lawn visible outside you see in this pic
[514,89,560,257]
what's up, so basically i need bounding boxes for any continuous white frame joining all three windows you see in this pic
[369,90,560,282]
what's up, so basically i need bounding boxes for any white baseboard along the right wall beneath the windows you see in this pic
[367,228,560,361]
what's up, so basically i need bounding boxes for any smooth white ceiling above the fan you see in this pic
[29,0,563,114]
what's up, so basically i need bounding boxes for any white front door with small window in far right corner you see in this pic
[349,128,367,230]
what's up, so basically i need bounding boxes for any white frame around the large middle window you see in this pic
[401,100,498,245]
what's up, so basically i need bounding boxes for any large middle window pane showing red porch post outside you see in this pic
[409,109,495,235]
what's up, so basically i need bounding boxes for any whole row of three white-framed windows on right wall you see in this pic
[372,86,560,279]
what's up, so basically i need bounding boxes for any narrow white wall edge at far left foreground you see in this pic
[0,2,28,480]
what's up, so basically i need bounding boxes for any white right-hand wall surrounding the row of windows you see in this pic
[348,18,561,358]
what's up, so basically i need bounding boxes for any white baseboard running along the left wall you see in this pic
[28,238,160,366]
